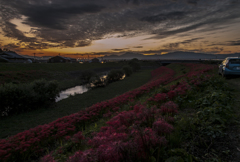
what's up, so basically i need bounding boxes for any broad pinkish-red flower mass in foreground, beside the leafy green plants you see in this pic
[65,63,216,162]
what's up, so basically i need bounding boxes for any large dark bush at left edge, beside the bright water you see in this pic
[0,80,59,117]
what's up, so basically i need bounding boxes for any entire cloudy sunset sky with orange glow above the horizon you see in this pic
[0,0,240,57]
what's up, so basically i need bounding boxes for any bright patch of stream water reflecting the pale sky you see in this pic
[56,85,88,102]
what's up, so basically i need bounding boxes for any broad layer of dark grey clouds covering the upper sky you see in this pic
[0,0,240,49]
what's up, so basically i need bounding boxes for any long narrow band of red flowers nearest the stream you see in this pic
[0,67,174,160]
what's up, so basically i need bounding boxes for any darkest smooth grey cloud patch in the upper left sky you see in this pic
[20,4,104,30]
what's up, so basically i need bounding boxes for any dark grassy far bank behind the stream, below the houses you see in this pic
[0,61,158,90]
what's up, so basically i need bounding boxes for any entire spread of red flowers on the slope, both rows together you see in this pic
[0,64,214,162]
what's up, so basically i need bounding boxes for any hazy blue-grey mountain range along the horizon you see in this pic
[103,51,240,60]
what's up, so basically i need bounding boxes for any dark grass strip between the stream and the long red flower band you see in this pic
[0,70,151,138]
